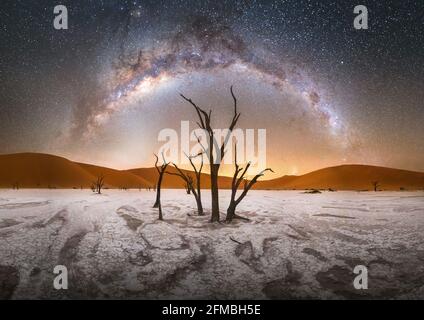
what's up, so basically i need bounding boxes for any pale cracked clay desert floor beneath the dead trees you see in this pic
[0,189,424,299]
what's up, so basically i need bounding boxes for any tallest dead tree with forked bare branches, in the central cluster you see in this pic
[181,86,240,222]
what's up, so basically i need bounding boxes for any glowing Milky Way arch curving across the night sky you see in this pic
[75,17,345,144]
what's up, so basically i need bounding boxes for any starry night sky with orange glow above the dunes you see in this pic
[0,0,424,176]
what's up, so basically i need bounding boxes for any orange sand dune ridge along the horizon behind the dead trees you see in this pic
[0,153,424,190]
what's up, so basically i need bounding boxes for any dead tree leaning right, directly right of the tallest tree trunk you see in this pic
[226,145,274,222]
